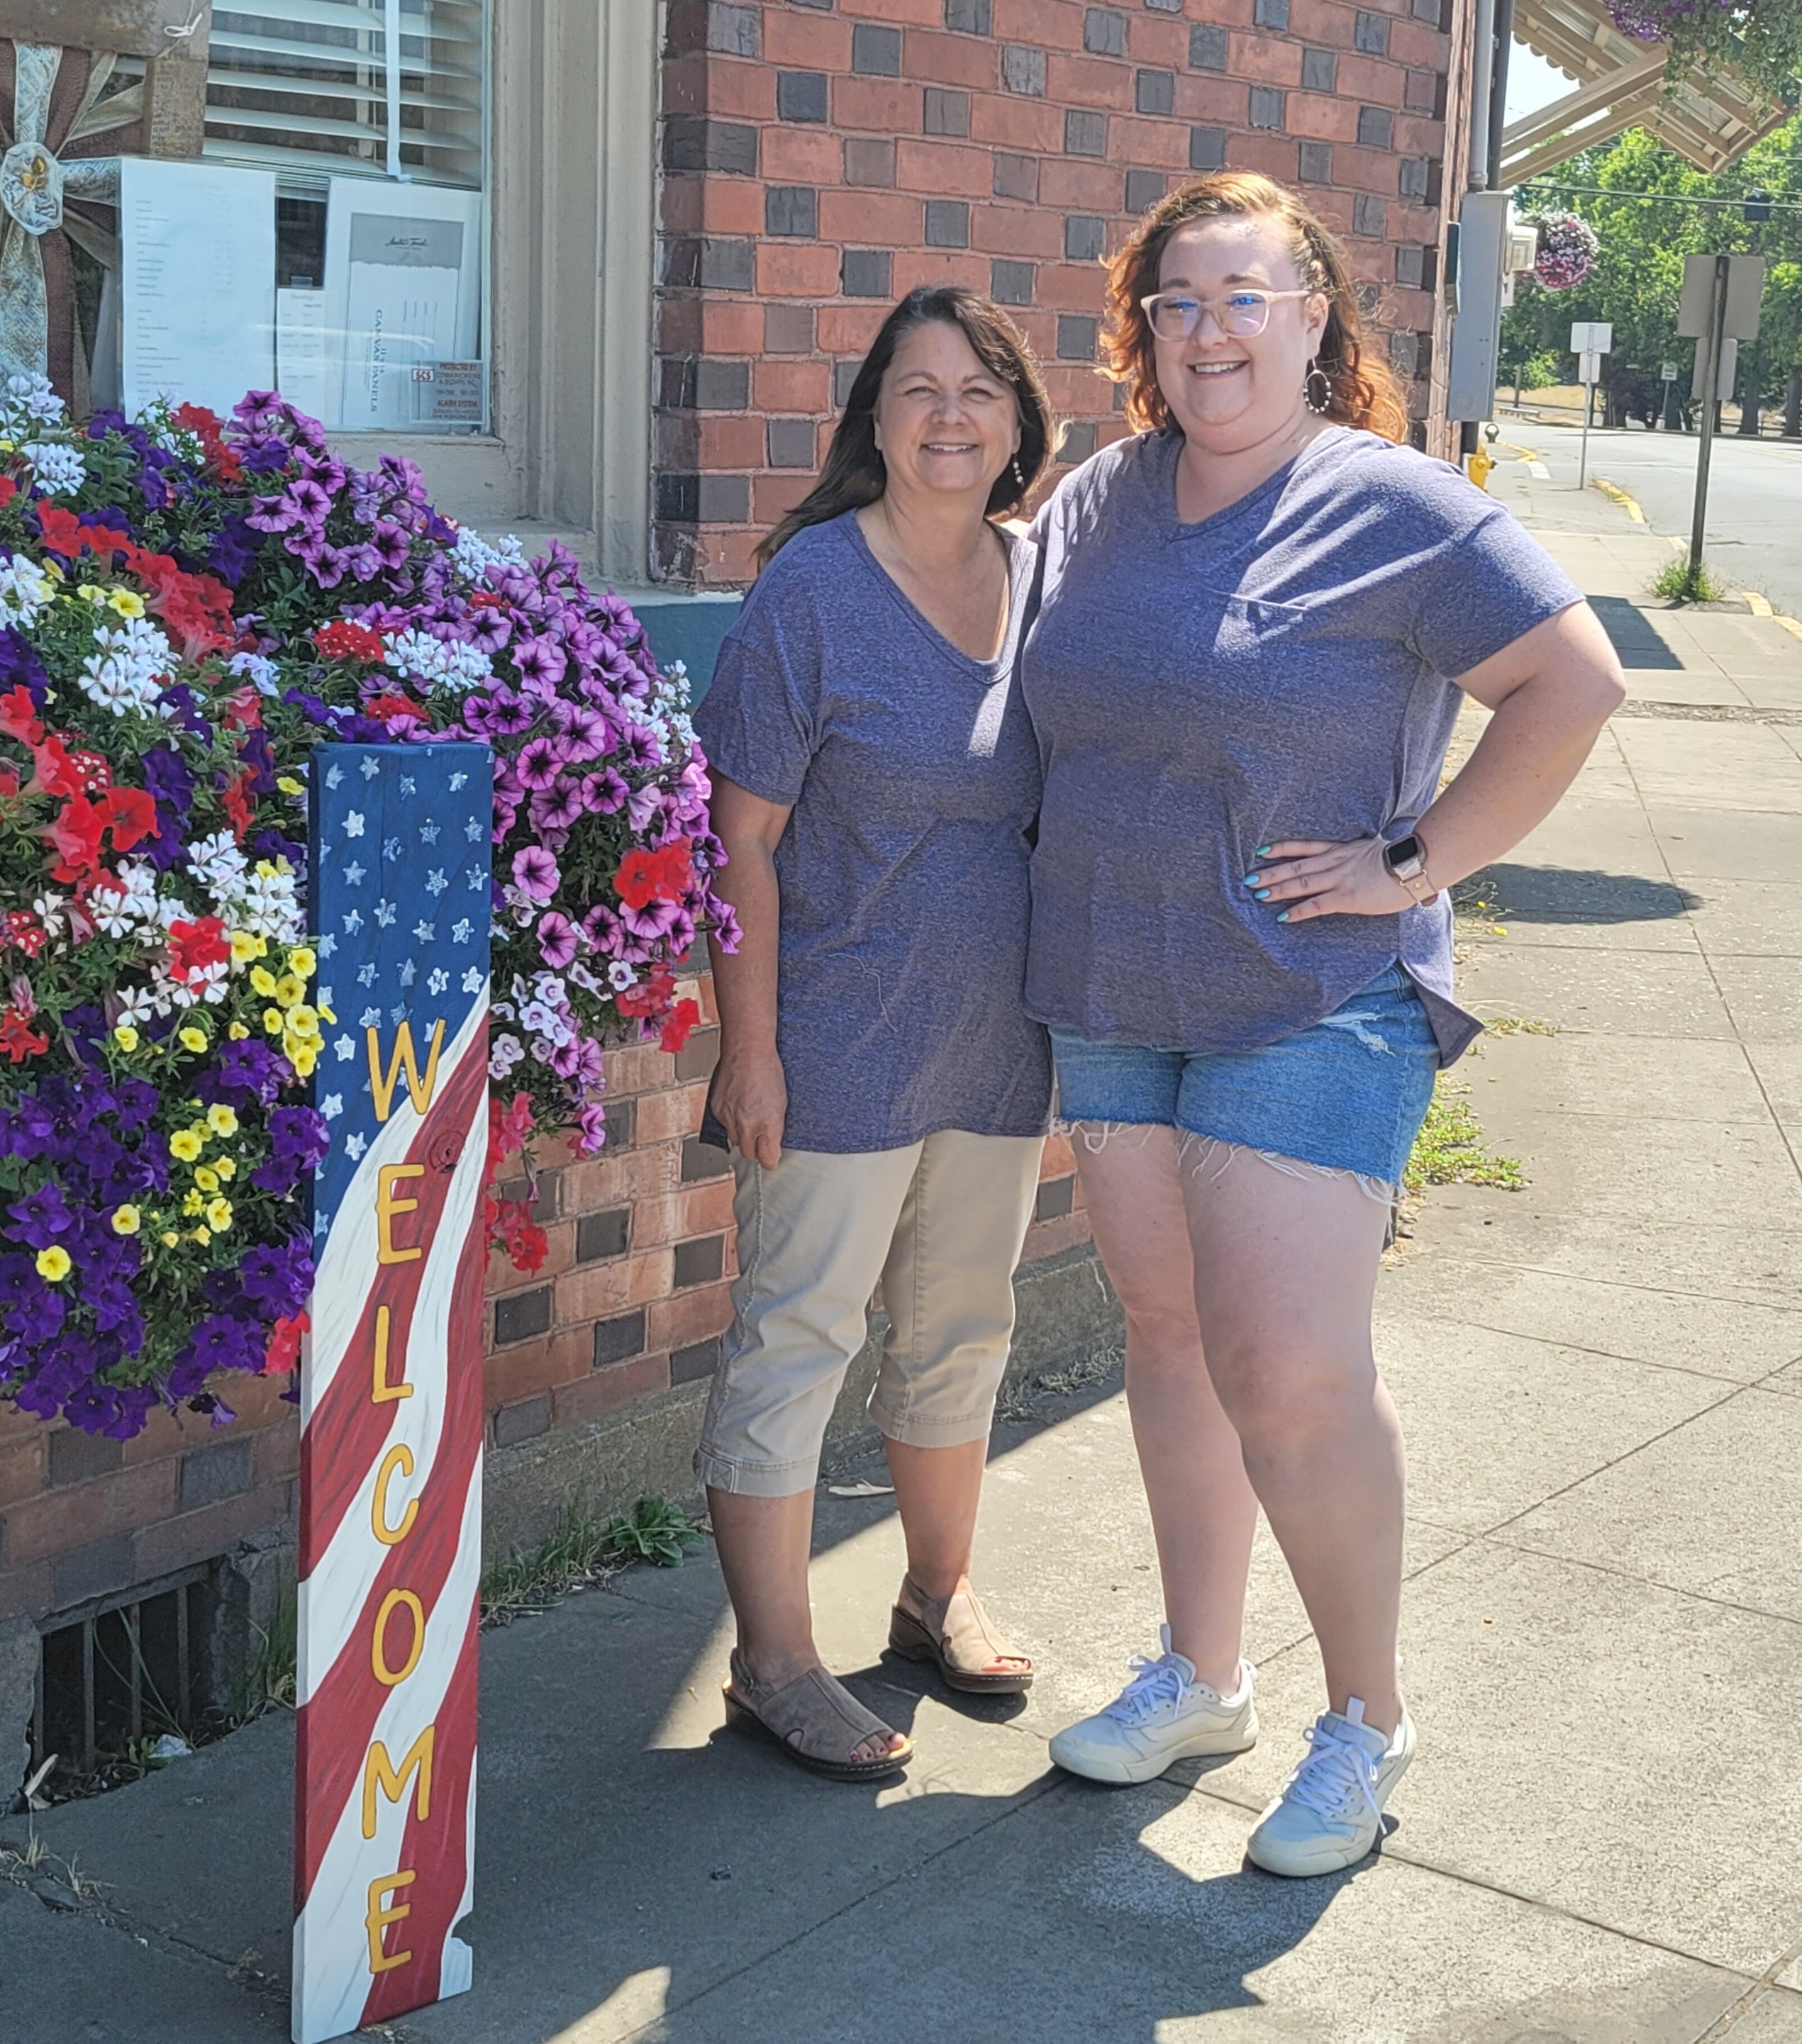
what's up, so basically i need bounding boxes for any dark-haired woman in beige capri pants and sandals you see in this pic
[696,289,1051,1780]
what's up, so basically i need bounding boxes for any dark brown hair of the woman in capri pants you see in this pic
[757,284,1051,568]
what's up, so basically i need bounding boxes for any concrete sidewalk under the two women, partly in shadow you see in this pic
[0,462,1802,2044]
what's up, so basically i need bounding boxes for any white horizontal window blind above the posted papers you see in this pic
[206,0,486,190]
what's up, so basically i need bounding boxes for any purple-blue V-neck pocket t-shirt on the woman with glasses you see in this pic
[1020,428,1581,1063]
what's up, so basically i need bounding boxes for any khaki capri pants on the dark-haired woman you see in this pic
[696,1128,1043,1498]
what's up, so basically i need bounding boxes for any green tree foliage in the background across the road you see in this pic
[1501,121,1802,415]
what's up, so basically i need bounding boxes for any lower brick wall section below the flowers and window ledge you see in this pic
[0,948,1088,1621]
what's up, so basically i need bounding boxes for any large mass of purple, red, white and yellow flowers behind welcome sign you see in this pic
[0,376,736,1439]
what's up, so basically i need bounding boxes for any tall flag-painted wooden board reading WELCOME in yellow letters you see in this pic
[292,744,493,2044]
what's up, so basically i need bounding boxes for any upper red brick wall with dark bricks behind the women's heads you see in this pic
[652,0,1469,586]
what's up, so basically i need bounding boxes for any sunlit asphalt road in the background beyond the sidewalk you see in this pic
[1497,415,1802,618]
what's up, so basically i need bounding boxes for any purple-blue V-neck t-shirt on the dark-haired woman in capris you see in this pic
[696,511,1051,1151]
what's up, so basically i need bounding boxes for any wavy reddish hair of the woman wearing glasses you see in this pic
[1103,169,1407,440]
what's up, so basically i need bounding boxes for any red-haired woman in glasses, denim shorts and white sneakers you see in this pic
[1023,174,1622,1875]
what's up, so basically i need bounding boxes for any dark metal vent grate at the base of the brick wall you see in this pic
[30,1565,206,1774]
